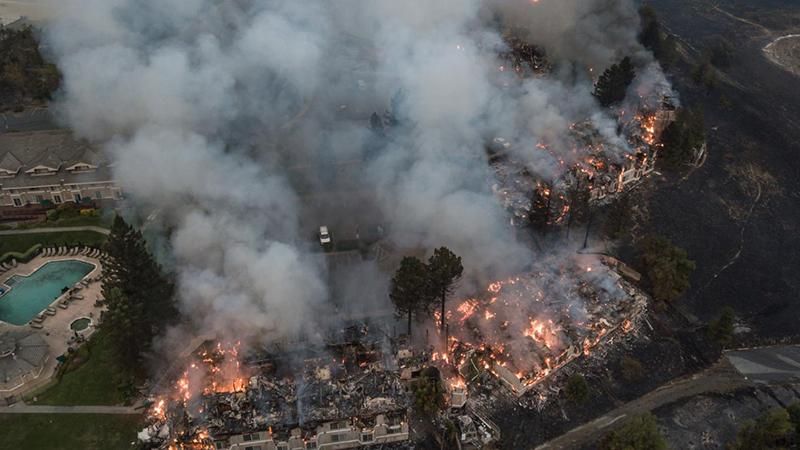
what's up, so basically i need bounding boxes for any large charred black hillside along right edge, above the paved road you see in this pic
[636,0,800,340]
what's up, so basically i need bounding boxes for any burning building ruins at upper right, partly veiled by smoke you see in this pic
[487,96,677,226]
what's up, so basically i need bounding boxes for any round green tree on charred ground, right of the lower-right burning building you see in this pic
[639,236,696,302]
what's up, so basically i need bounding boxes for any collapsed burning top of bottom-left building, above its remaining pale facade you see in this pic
[140,330,408,448]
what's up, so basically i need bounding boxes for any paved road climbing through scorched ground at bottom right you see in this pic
[536,346,800,450]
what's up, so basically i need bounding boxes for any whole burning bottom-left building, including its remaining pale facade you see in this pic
[139,334,409,450]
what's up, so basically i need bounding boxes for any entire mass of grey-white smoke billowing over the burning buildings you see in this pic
[48,0,664,350]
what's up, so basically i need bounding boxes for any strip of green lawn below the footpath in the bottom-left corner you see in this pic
[0,414,144,450]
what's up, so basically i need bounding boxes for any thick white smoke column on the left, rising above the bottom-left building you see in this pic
[49,0,327,340]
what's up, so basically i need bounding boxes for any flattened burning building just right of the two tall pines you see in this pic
[433,257,648,396]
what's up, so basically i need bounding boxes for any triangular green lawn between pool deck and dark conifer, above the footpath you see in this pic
[35,330,126,405]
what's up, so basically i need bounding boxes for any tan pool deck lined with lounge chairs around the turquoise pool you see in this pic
[0,255,103,397]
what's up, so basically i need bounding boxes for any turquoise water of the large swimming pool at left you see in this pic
[0,260,94,325]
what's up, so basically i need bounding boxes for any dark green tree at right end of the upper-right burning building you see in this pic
[661,108,706,169]
